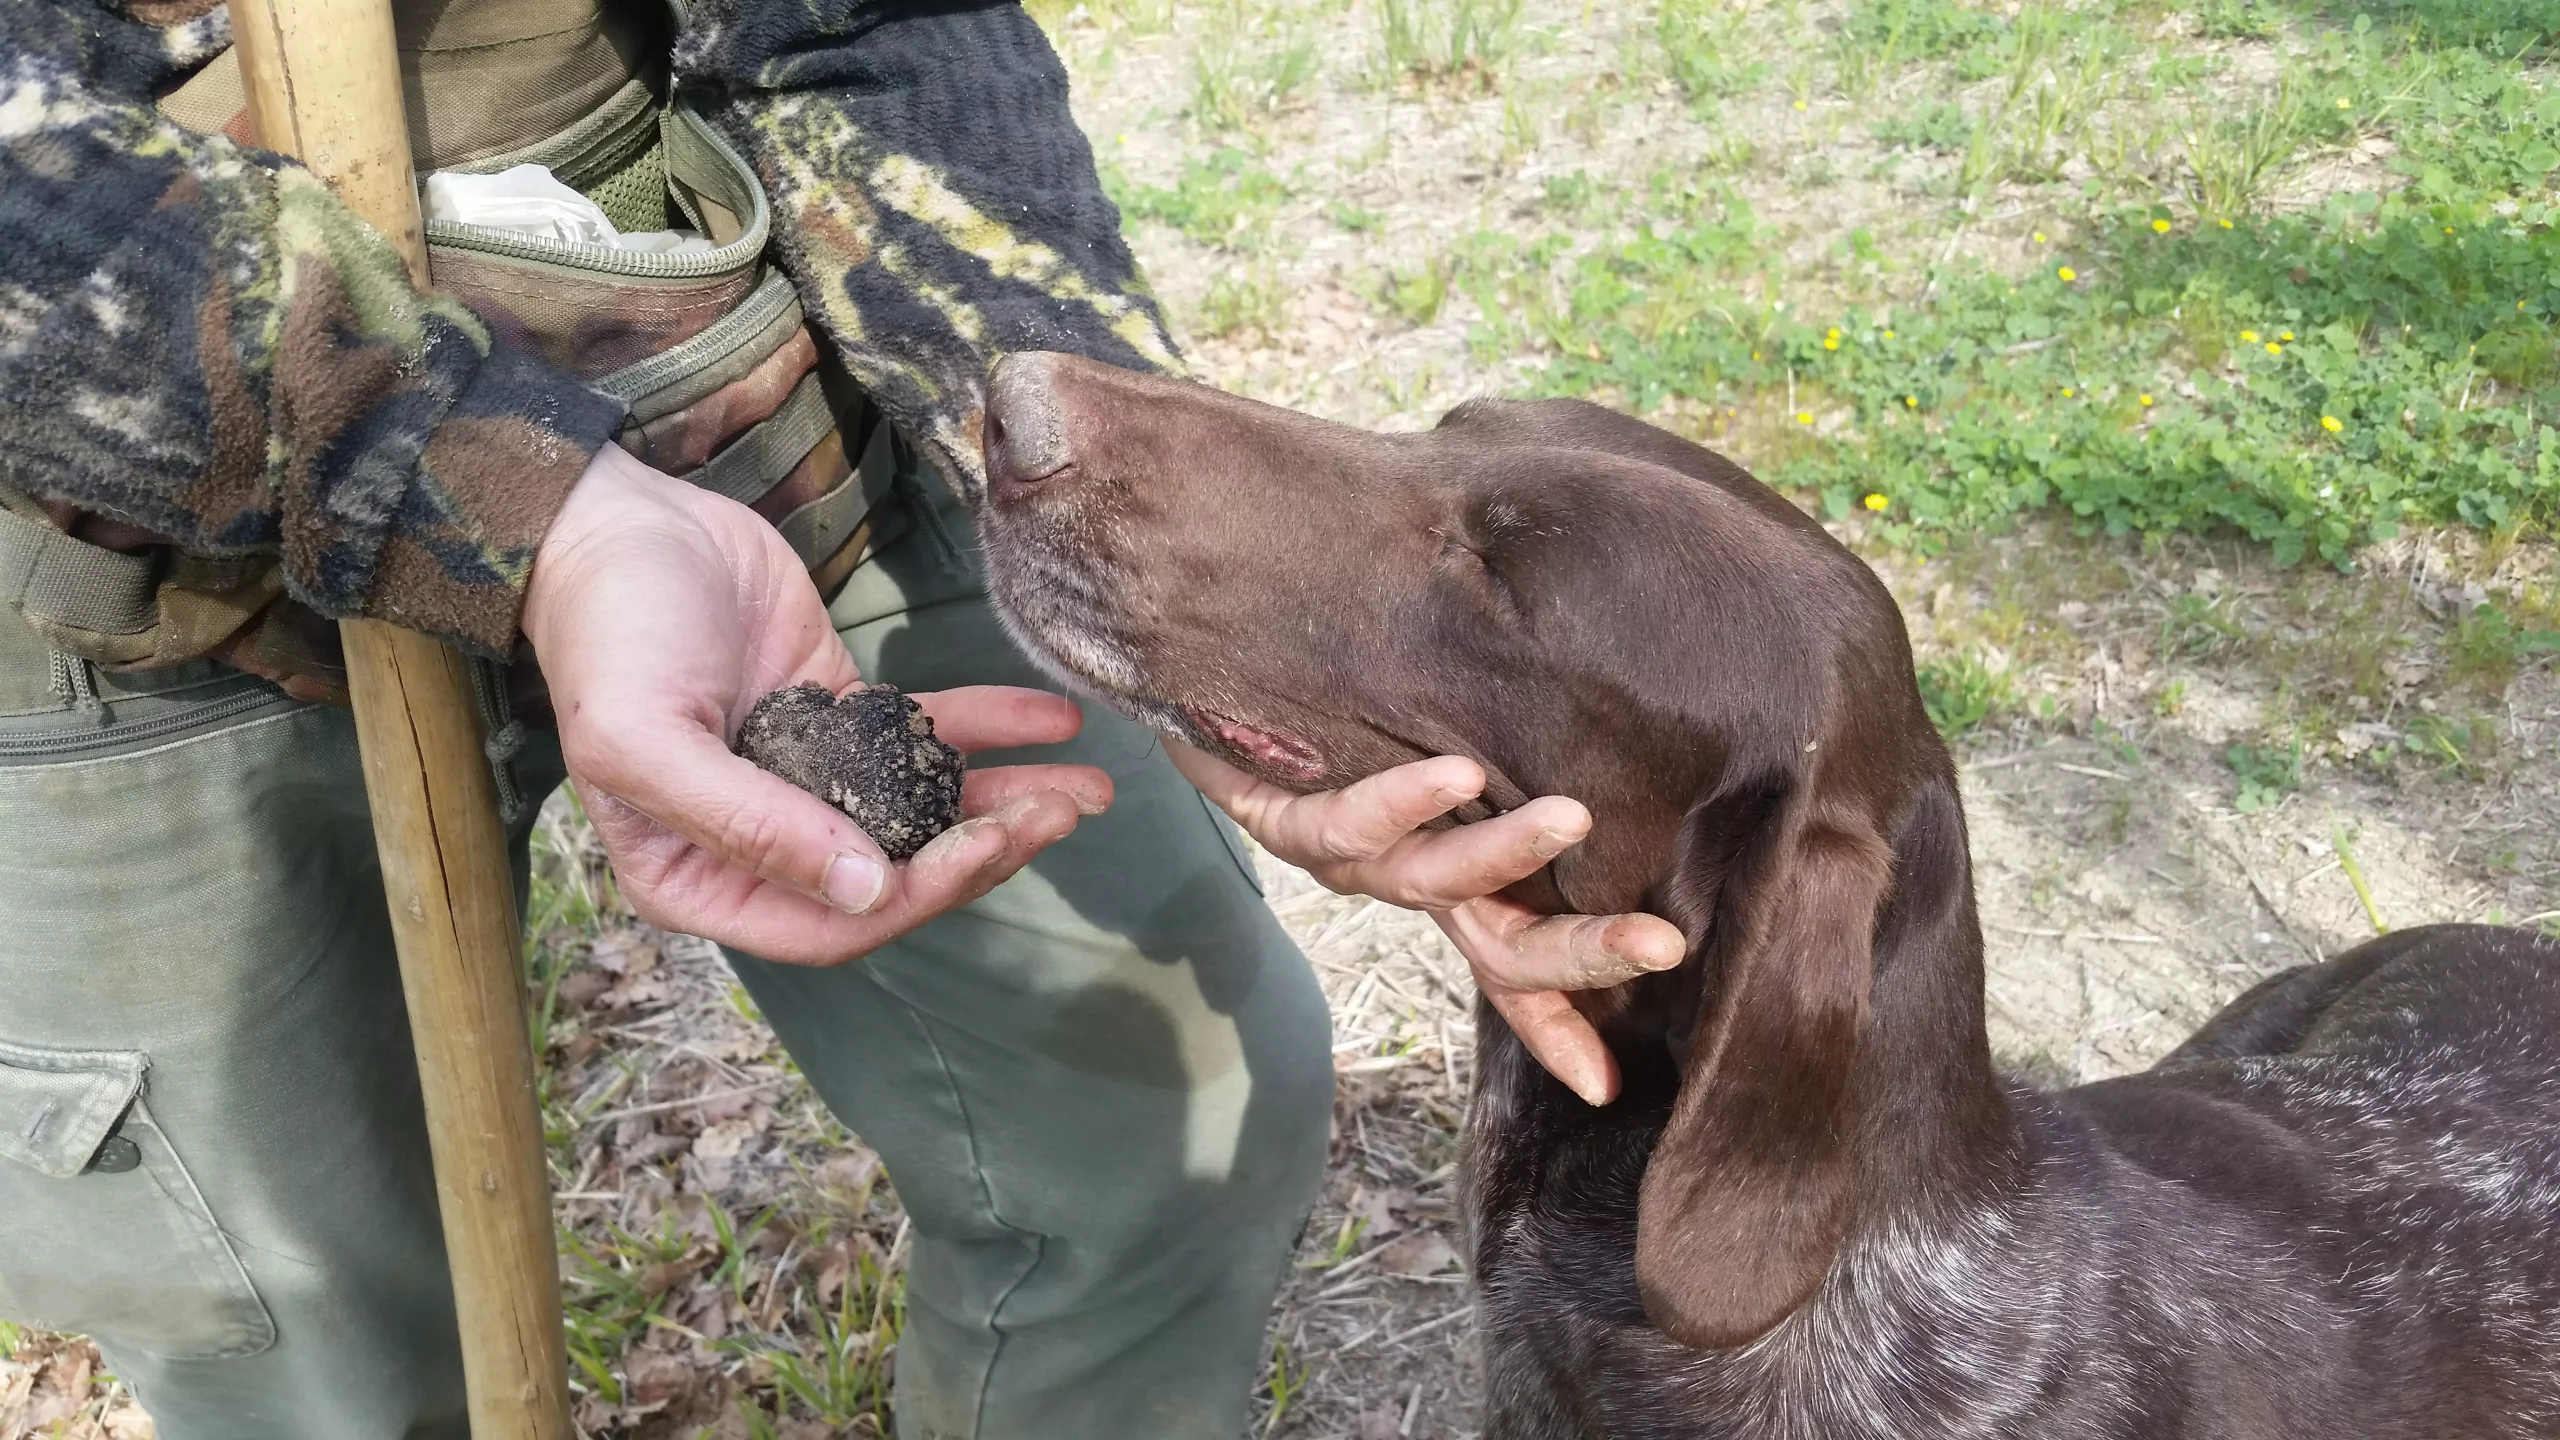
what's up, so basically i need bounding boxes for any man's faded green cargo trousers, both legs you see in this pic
[0,481,1331,1440]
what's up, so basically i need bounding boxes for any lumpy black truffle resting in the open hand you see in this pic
[737,684,968,861]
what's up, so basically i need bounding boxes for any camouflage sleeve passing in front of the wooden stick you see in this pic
[0,0,622,648]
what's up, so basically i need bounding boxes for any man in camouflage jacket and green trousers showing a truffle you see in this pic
[0,0,1679,1440]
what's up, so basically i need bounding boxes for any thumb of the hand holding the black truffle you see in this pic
[571,720,891,915]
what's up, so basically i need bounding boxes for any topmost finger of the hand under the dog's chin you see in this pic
[1165,740,1485,866]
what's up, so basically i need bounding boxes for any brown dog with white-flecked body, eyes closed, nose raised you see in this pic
[980,356,2560,1440]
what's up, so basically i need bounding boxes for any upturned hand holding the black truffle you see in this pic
[525,446,1111,966]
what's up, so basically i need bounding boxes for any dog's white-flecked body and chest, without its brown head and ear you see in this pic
[1480,928,2560,1440]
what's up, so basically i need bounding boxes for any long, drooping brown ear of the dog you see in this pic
[1636,794,1892,1348]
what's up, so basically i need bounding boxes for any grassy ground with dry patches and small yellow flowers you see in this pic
[0,0,2560,1440]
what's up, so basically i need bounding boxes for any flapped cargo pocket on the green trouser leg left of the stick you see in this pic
[0,1043,276,1361]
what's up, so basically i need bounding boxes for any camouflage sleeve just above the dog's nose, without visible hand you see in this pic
[676,0,1180,497]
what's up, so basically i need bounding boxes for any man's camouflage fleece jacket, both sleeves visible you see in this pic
[0,0,1175,651]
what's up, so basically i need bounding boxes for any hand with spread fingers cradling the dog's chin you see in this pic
[1165,740,1687,1104]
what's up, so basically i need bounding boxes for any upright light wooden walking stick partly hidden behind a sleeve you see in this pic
[230,0,568,1440]
